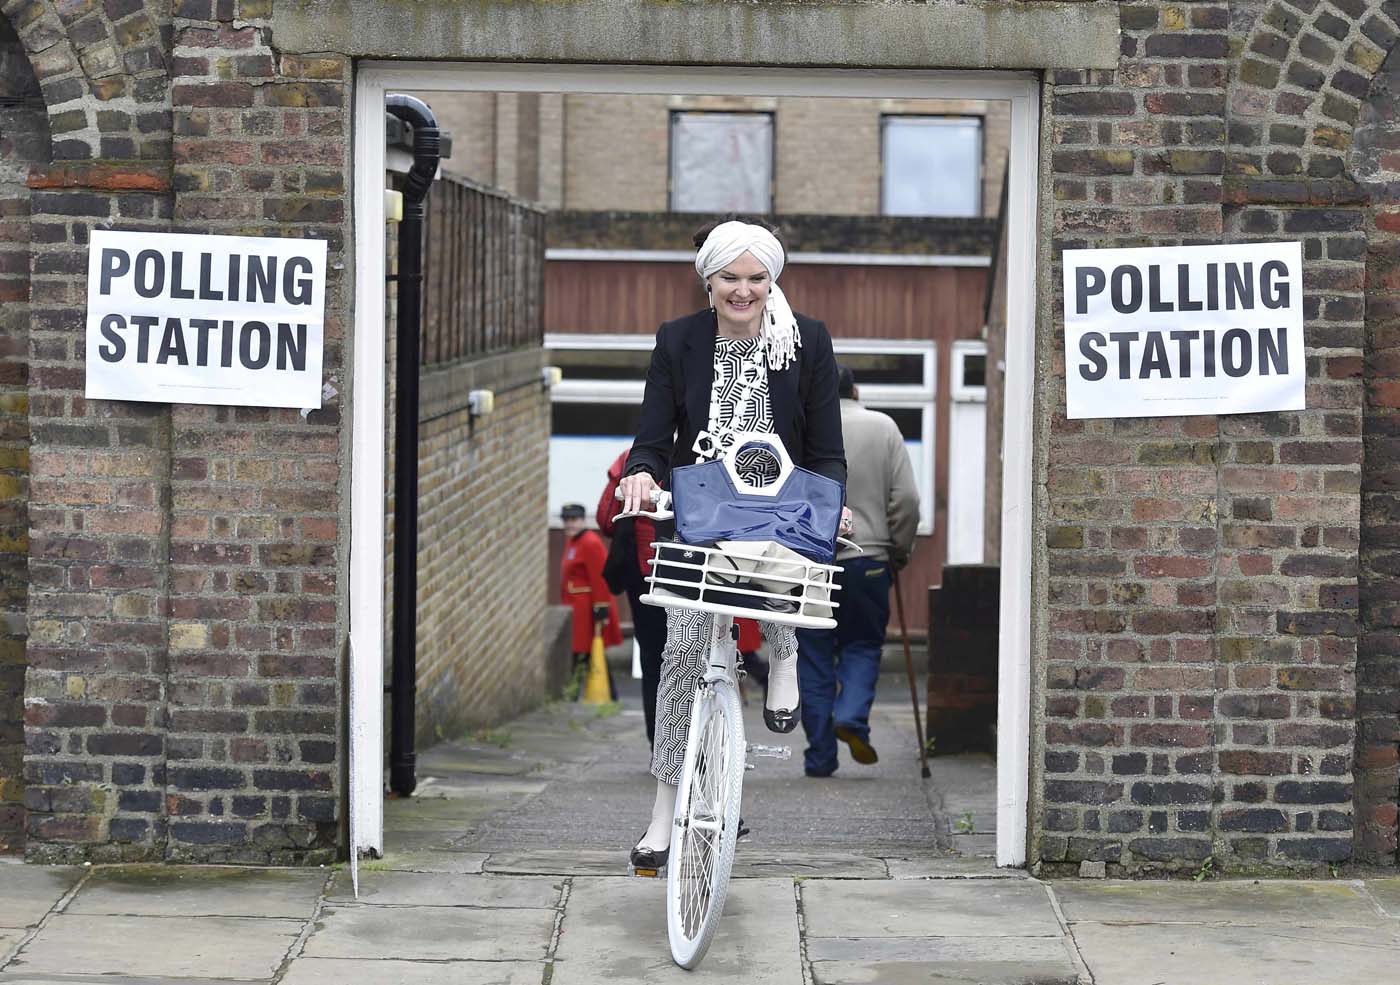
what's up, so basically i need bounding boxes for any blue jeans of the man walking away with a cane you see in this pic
[797,557,890,775]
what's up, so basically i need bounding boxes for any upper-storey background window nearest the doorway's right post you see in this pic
[881,116,981,217]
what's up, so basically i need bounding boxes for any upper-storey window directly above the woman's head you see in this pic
[671,112,773,213]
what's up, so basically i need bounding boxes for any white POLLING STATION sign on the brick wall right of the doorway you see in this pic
[1064,242,1306,418]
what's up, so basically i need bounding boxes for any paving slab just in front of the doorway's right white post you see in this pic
[801,879,1061,939]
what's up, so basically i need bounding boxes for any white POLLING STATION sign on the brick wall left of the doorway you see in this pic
[84,229,326,409]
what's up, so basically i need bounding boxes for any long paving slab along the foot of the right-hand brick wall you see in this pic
[1054,880,1385,928]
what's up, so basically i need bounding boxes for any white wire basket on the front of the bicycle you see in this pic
[641,540,840,630]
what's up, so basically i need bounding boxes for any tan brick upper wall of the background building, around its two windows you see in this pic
[419,92,1011,217]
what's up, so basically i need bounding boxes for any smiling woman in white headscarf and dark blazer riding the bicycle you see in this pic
[617,218,850,869]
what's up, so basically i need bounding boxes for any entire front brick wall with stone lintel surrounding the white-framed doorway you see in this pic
[0,0,1400,872]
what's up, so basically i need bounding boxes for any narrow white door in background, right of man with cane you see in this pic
[948,341,987,564]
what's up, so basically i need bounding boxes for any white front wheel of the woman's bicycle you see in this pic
[666,681,746,968]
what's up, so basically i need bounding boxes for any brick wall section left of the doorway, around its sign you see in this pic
[4,0,349,862]
